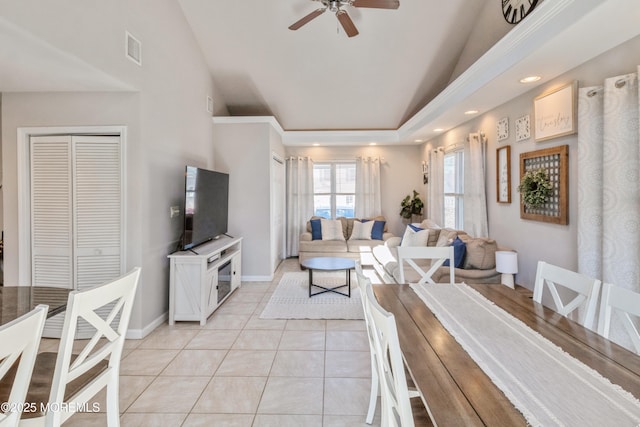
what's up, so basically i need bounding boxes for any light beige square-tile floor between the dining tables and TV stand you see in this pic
[55,259,429,427]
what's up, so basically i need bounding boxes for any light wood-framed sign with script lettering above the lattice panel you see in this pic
[533,81,578,141]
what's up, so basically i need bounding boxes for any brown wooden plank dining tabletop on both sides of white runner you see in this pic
[373,284,640,427]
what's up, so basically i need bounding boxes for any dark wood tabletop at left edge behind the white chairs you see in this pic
[0,286,72,325]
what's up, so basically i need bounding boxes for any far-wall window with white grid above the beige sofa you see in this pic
[313,162,356,219]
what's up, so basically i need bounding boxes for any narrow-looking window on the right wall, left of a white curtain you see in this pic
[444,151,464,230]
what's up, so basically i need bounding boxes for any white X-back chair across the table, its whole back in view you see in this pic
[533,261,601,329]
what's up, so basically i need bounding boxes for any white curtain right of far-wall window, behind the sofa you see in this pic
[355,157,382,218]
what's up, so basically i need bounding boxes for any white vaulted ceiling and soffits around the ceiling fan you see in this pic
[0,0,640,145]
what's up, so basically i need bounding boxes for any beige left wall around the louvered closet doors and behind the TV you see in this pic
[0,0,226,333]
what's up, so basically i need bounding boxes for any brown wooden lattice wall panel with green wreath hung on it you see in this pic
[518,145,569,225]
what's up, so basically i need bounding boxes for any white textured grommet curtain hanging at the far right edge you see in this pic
[578,70,640,349]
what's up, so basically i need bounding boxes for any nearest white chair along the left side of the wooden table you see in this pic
[365,286,414,427]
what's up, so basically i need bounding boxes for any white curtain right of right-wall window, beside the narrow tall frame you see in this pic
[464,133,489,237]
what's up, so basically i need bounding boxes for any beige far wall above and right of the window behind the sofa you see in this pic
[286,145,426,236]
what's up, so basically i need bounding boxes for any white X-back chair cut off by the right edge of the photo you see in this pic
[598,283,640,354]
